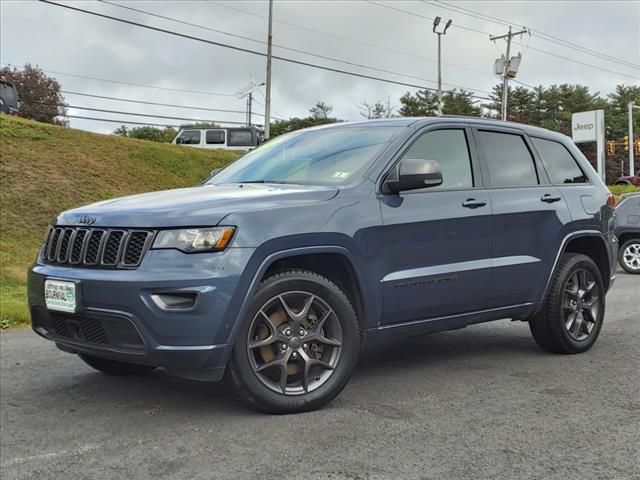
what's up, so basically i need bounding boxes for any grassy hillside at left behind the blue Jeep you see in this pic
[0,115,238,328]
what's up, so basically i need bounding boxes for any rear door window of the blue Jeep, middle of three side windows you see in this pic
[478,130,538,187]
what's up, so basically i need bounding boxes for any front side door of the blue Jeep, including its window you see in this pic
[379,124,492,324]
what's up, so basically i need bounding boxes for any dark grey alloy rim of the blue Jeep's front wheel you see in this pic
[247,291,342,395]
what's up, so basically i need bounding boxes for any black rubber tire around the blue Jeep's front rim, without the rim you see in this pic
[230,271,360,413]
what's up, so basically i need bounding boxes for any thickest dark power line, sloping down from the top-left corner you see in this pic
[38,0,487,100]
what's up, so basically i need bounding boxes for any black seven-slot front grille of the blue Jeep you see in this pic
[43,227,154,268]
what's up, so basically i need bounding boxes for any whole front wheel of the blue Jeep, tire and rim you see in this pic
[227,270,361,413]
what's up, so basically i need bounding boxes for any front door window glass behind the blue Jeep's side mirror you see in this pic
[402,129,473,190]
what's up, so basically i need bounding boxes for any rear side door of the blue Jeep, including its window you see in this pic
[474,127,571,308]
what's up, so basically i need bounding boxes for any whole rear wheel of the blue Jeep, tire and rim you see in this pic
[529,253,605,354]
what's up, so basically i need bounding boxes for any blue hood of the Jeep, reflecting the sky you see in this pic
[56,183,338,228]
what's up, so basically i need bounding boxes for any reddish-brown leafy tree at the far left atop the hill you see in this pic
[0,63,68,125]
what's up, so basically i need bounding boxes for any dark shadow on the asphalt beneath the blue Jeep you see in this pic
[27,320,541,416]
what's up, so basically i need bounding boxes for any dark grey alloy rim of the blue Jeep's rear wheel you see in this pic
[562,269,601,341]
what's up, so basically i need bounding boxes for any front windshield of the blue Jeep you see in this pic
[207,126,402,185]
